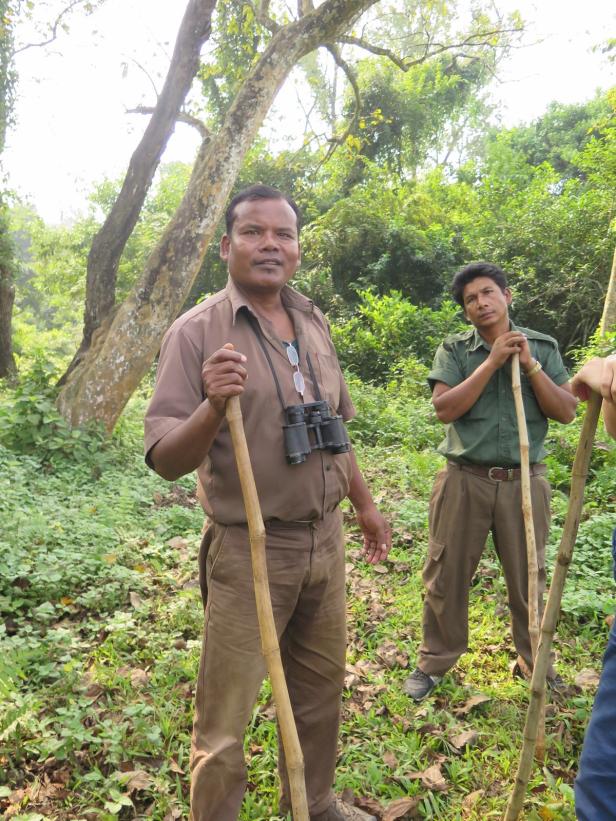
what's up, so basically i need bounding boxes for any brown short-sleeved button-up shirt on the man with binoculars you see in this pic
[145,279,355,525]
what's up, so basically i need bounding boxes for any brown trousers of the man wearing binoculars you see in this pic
[190,511,346,821]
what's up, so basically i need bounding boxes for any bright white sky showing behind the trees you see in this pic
[4,0,616,222]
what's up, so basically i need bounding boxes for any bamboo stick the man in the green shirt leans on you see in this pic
[511,354,545,761]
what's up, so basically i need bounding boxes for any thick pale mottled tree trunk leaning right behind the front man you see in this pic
[58,0,377,430]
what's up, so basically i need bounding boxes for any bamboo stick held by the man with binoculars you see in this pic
[226,396,309,821]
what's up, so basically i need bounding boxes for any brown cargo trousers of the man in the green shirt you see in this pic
[418,463,554,677]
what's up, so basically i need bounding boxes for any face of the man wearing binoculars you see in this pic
[220,199,300,294]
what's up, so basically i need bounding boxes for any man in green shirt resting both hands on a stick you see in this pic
[404,262,577,701]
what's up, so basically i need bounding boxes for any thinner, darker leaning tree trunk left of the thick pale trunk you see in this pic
[60,0,216,384]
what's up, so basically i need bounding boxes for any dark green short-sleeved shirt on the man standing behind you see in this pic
[428,322,569,467]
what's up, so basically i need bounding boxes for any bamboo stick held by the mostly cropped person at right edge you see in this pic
[504,253,616,821]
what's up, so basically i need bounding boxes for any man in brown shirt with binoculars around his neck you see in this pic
[145,186,391,821]
